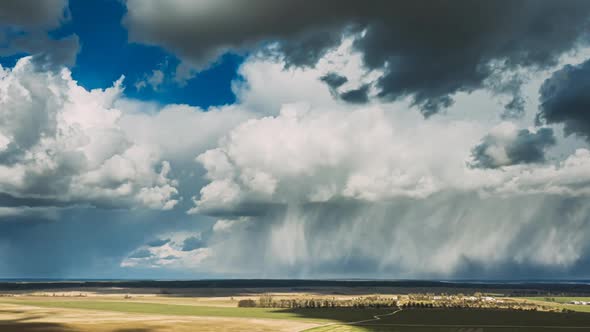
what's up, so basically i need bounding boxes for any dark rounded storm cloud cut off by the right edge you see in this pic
[537,60,590,140]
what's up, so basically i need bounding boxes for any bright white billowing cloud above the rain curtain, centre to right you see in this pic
[190,99,590,216]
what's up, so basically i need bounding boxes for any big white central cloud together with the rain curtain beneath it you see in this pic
[186,89,590,278]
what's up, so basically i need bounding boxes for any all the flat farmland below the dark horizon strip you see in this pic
[0,284,590,332]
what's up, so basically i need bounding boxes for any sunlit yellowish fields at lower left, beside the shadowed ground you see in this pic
[0,291,385,332]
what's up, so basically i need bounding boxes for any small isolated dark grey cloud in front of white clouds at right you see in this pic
[471,128,556,168]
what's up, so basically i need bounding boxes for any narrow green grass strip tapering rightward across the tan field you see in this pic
[0,299,390,323]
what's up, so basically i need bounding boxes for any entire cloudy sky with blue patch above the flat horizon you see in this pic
[0,0,590,279]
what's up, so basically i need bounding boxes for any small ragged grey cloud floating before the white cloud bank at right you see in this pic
[471,122,556,168]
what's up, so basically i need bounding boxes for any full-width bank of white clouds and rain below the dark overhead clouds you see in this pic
[5,34,590,278]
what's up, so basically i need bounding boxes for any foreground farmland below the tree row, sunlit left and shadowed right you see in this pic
[0,297,590,332]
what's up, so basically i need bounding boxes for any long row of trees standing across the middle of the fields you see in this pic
[238,295,397,309]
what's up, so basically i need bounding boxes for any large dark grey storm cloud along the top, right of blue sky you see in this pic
[124,0,590,115]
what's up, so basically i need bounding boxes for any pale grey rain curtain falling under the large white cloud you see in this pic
[209,193,590,278]
